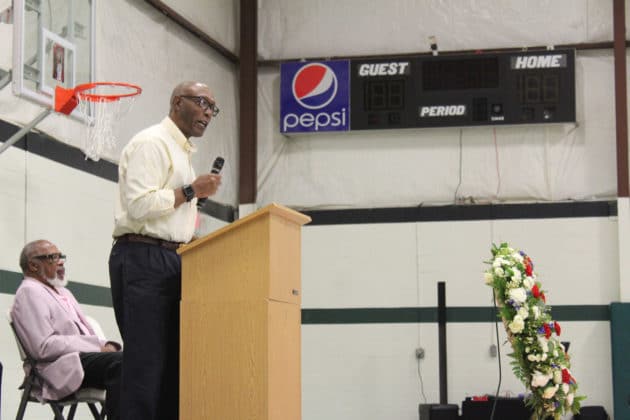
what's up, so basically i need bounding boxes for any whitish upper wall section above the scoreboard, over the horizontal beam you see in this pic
[258,0,630,60]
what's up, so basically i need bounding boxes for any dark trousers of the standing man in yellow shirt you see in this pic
[109,242,181,420]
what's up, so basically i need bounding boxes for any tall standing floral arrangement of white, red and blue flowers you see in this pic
[485,243,585,420]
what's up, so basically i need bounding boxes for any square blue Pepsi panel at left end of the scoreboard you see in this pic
[280,60,350,133]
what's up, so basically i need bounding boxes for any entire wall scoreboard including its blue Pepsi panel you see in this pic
[280,49,575,133]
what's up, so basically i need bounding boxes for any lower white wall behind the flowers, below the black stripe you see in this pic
[302,218,619,420]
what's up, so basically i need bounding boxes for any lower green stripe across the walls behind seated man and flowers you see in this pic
[0,270,610,324]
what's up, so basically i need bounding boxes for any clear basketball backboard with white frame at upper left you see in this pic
[13,0,96,107]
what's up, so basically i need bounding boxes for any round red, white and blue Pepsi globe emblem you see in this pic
[292,63,339,109]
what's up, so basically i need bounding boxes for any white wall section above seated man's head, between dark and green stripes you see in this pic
[0,148,116,286]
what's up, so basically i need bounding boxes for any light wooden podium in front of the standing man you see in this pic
[177,204,311,420]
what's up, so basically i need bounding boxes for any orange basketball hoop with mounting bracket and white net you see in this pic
[55,82,142,161]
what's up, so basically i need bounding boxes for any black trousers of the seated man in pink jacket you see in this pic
[79,352,123,420]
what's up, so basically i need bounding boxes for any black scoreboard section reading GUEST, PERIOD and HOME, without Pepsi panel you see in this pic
[349,50,575,130]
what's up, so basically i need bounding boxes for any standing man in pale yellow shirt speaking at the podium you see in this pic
[109,82,221,420]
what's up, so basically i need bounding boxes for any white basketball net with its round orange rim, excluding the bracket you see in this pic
[77,85,136,161]
